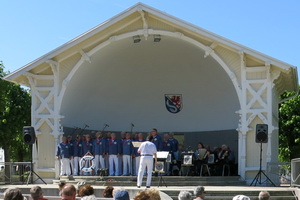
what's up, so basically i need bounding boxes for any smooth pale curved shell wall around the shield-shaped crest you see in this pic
[61,37,240,132]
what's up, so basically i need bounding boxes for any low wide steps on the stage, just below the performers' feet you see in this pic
[53,176,246,186]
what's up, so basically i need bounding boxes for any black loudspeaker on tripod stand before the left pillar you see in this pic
[23,126,47,185]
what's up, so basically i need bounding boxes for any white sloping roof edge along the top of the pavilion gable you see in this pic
[3,3,298,90]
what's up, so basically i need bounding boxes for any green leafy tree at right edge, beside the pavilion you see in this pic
[279,86,300,162]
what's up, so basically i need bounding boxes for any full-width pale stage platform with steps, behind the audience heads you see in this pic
[0,176,298,200]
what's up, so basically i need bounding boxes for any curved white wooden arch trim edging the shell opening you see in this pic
[58,29,241,111]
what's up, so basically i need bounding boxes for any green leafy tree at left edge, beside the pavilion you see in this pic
[0,62,31,162]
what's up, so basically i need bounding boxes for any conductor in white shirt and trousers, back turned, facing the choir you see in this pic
[137,136,157,188]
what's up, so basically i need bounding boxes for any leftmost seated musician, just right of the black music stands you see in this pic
[194,142,210,175]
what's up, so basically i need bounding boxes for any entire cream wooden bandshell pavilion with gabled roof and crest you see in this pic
[4,3,298,181]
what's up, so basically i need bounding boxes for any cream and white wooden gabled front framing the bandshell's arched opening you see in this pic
[4,3,298,180]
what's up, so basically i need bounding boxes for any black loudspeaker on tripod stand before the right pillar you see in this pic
[250,124,275,186]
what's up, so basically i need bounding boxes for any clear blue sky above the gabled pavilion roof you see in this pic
[0,0,300,81]
